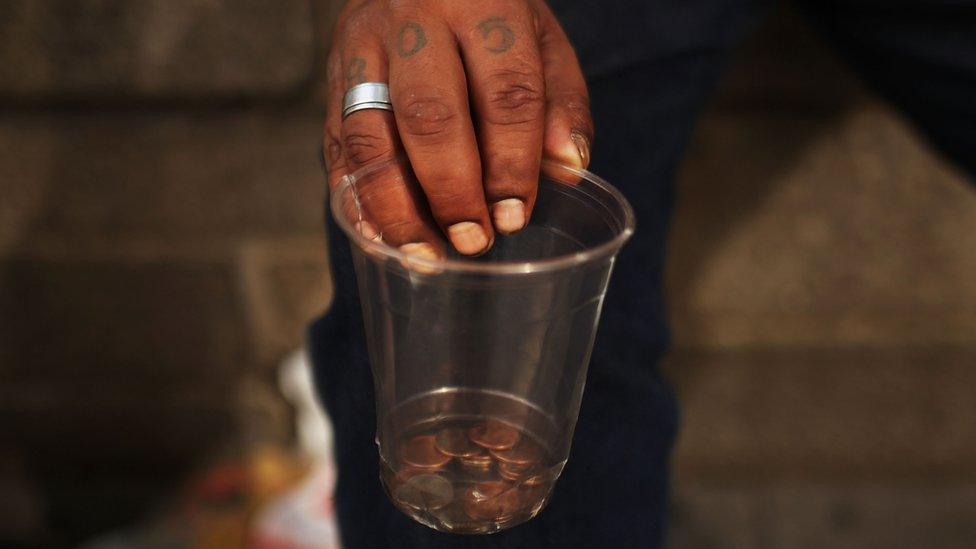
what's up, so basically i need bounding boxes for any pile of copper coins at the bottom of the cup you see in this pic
[384,421,556,533]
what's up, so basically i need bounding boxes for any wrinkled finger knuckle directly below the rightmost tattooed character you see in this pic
[485,71,545,125]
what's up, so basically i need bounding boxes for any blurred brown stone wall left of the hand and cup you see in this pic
[0,0,336,546]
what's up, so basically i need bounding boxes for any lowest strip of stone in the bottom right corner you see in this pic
[668,479,976,549]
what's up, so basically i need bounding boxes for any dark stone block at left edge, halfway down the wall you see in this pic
[0,257,246,386]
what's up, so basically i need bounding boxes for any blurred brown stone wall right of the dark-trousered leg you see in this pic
[666,6,976,548]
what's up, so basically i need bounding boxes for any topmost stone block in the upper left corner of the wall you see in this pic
[0,0,317,101]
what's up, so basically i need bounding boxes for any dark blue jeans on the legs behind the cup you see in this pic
[309,0,976,549]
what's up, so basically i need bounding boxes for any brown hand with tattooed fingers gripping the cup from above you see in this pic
[324,0,593,257]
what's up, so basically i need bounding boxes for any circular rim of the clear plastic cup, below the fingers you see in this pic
[329,157,636,275]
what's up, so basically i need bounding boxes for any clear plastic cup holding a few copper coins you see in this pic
[331,156,634,534]
